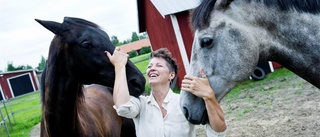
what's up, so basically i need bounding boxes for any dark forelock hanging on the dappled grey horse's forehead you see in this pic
[191,0,216,30]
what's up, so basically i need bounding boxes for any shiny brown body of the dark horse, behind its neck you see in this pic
[77,85,135,137]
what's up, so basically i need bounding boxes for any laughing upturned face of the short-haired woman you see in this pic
[146,57,174,86]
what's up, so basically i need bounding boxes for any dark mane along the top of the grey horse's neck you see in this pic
[249,0,320,14]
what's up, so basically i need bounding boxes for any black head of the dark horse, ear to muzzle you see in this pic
[36,17,145,96]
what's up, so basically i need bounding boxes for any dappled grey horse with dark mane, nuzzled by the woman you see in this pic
[181,0,320,124]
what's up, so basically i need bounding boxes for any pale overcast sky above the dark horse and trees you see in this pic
[0,0,138,71]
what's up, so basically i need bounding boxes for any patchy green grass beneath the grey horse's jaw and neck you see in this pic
[223,68,301,120]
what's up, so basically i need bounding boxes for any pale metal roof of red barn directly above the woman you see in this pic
[151,0,200,17]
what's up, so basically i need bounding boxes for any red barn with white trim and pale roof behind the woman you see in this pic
[137,0,199,86]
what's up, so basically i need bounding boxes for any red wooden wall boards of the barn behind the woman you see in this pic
[138,0,193,87]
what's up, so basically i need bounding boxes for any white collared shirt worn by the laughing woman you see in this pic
[114,89,226,137]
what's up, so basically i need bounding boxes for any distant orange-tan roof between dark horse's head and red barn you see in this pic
[120,38,151,53]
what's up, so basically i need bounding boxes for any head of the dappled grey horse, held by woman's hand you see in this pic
[181,0,259,124]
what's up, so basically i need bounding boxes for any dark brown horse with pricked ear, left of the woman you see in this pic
[36,17,145,137]
